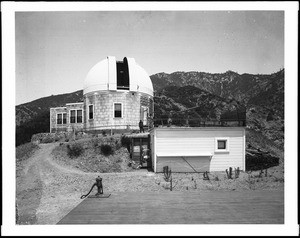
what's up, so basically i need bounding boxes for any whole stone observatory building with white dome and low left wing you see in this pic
[50,56,154,132]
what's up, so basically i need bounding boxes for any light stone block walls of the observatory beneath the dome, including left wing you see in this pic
[50,91,153,132]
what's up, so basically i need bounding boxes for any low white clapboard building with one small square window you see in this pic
[150,127,245,172]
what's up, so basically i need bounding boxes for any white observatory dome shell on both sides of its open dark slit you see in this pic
[83,56,153,96]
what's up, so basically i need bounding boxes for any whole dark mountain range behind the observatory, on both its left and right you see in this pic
[16,69,284,148]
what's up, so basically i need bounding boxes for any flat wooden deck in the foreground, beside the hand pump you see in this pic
[58,190,284,224]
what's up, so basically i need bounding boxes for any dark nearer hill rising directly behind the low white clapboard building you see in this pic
[154,86,244,121]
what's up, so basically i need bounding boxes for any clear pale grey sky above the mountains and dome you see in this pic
[15,10,284,105]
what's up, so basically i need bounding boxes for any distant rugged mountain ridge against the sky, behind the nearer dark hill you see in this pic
[150,70,284,116]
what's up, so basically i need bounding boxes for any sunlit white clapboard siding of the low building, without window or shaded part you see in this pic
[153,127,245,172]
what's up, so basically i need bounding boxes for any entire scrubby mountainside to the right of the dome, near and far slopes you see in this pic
[150,70,284,149]
